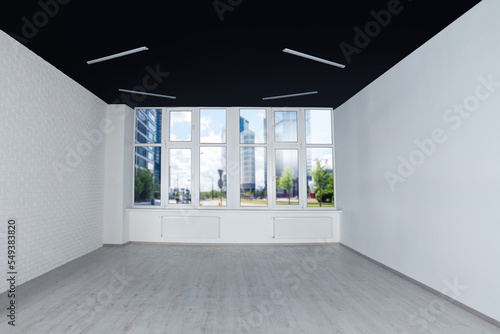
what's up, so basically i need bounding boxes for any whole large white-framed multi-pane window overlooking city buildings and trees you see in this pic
[134,107,335,210]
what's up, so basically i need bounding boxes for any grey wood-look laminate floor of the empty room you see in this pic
[0,244,500,334]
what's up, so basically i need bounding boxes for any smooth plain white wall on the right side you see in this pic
[335,0,500,320]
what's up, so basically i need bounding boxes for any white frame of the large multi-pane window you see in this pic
[132,107,338,211]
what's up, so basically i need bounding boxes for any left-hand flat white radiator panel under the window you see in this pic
[161,217,220,238]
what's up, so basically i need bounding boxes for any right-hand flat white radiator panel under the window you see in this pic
[274,217,333,241]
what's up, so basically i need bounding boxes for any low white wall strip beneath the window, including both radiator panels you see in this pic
[127,208,341,244]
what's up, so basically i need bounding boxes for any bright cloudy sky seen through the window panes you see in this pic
[169,108,333,191]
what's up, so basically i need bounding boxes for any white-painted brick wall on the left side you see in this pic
[0,31,107,293]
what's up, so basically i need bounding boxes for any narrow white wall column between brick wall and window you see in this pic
[103,105,134,244]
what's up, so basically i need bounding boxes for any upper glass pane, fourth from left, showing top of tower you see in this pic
[240,109,267,144]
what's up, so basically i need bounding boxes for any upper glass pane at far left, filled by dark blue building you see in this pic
[135,109,162,144]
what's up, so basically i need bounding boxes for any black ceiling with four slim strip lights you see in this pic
[0,0,479,108]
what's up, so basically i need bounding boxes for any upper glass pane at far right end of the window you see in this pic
[306,110,332,144]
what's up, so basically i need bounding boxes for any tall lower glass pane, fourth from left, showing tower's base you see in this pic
[240,147,267,206]
